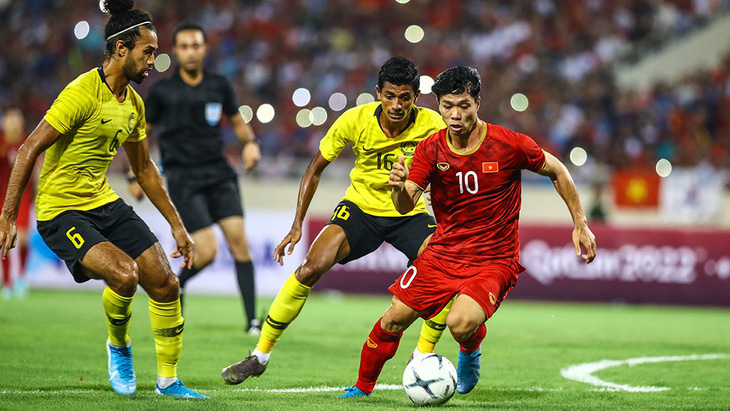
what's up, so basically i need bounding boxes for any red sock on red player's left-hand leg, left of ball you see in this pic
[355,317,403,394]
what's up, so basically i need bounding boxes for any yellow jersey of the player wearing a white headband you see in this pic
[36,68,147,221]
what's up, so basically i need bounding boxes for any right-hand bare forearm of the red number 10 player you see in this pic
[539,151,597,264]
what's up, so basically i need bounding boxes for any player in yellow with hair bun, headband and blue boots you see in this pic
[0,0,207,398]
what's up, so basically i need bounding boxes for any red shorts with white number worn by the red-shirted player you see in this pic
[389,252,522,318]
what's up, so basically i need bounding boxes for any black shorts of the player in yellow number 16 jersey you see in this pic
[327,200,436,265]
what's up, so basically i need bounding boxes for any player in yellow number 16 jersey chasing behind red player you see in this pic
[221,57,448,384]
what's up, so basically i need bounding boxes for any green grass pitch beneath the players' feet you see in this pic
[0,290,730,410]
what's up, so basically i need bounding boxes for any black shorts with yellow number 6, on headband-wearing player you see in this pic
[38,198,157,283]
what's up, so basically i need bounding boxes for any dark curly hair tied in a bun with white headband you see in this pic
[102,0,155,57]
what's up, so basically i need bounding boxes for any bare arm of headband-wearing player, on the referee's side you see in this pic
[124,140,195,268]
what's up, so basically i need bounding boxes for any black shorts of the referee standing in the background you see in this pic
[167,172,243,233]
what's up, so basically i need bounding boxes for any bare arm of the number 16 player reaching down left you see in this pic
[274,152,330,265]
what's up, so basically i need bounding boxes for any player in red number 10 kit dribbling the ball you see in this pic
[341,67,596,398]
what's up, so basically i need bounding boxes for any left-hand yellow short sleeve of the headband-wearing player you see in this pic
[43,77,98,134]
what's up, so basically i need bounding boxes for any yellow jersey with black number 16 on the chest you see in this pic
[319,102,446,217]
